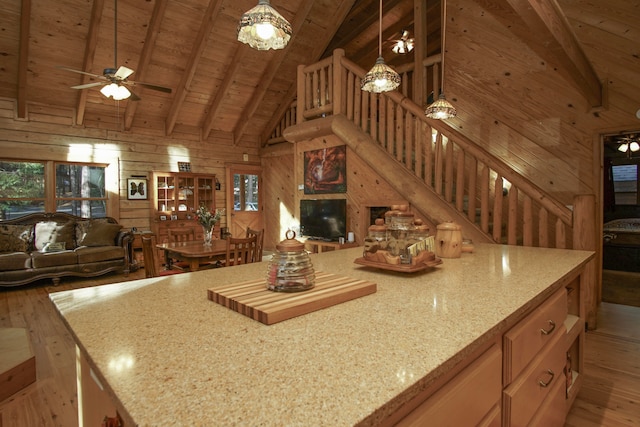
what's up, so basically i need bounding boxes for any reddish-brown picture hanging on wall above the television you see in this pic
[304,145,347,194]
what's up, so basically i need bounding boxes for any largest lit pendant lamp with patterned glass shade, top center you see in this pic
[238,0,292,50]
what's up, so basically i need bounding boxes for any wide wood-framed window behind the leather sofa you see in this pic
[0,160,107,220]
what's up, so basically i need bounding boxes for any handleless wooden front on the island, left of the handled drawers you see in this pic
[396,345,502,426]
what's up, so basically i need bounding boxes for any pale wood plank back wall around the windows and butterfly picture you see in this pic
[0,98,259,234]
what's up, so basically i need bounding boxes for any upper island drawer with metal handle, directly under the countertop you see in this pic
[503,288,567,386]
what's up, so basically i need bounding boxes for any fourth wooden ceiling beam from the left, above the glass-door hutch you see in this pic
[165,0,222,135]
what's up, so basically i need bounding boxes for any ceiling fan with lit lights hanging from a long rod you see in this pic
[58,0,171,101]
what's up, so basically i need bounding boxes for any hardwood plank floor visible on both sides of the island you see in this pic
[0,270,640,427]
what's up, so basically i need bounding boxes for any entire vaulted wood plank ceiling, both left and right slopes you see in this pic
[0,0,640,147]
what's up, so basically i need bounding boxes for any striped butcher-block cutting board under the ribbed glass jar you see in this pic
[207,272,377,325]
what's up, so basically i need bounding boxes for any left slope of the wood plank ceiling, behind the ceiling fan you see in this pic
[0,0,430,145]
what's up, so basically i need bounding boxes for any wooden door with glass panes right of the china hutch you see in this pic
[226,164,264,237]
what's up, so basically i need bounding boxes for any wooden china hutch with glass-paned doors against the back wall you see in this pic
[150,172,216,257]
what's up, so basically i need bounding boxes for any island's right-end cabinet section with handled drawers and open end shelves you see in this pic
[502,277,584,427]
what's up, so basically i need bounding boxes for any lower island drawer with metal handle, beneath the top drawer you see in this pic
[502,330,566,427]
